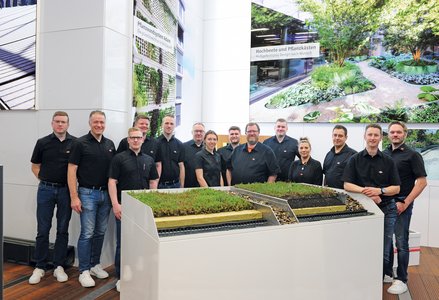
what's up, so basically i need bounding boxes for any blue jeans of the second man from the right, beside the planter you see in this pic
[380,199,398,278]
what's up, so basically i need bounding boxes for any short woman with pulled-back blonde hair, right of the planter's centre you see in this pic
[288,137,323,185]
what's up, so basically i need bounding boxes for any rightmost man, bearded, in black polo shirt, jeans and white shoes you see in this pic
[384,121,427,294]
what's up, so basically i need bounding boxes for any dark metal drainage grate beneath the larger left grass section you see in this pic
[158,220,268,237]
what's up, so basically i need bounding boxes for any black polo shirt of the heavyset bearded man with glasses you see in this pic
[227,143,280,185]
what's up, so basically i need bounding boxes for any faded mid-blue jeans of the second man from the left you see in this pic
[78,187,111,273]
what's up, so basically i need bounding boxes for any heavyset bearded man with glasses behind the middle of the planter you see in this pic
[227,123,280,185]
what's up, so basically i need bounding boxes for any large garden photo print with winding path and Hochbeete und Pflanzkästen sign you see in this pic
[250,0,439,123]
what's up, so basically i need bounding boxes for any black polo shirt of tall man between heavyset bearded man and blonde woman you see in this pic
[264,136,300,181]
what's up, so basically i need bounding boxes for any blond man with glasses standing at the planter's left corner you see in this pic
[108,128,159,291]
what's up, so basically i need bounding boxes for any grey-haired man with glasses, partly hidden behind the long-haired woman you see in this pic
[183,122,206,187]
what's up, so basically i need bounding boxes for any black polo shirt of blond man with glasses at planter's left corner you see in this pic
[108,149,159,203]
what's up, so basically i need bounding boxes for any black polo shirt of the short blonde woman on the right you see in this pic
[288,157,323,185]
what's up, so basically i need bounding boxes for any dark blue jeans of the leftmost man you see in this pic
[34,183,72,269]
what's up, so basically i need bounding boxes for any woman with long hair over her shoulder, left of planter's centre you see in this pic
[195,130,224,187]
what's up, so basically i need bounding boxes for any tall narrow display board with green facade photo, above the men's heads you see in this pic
[132,0,177,136]
